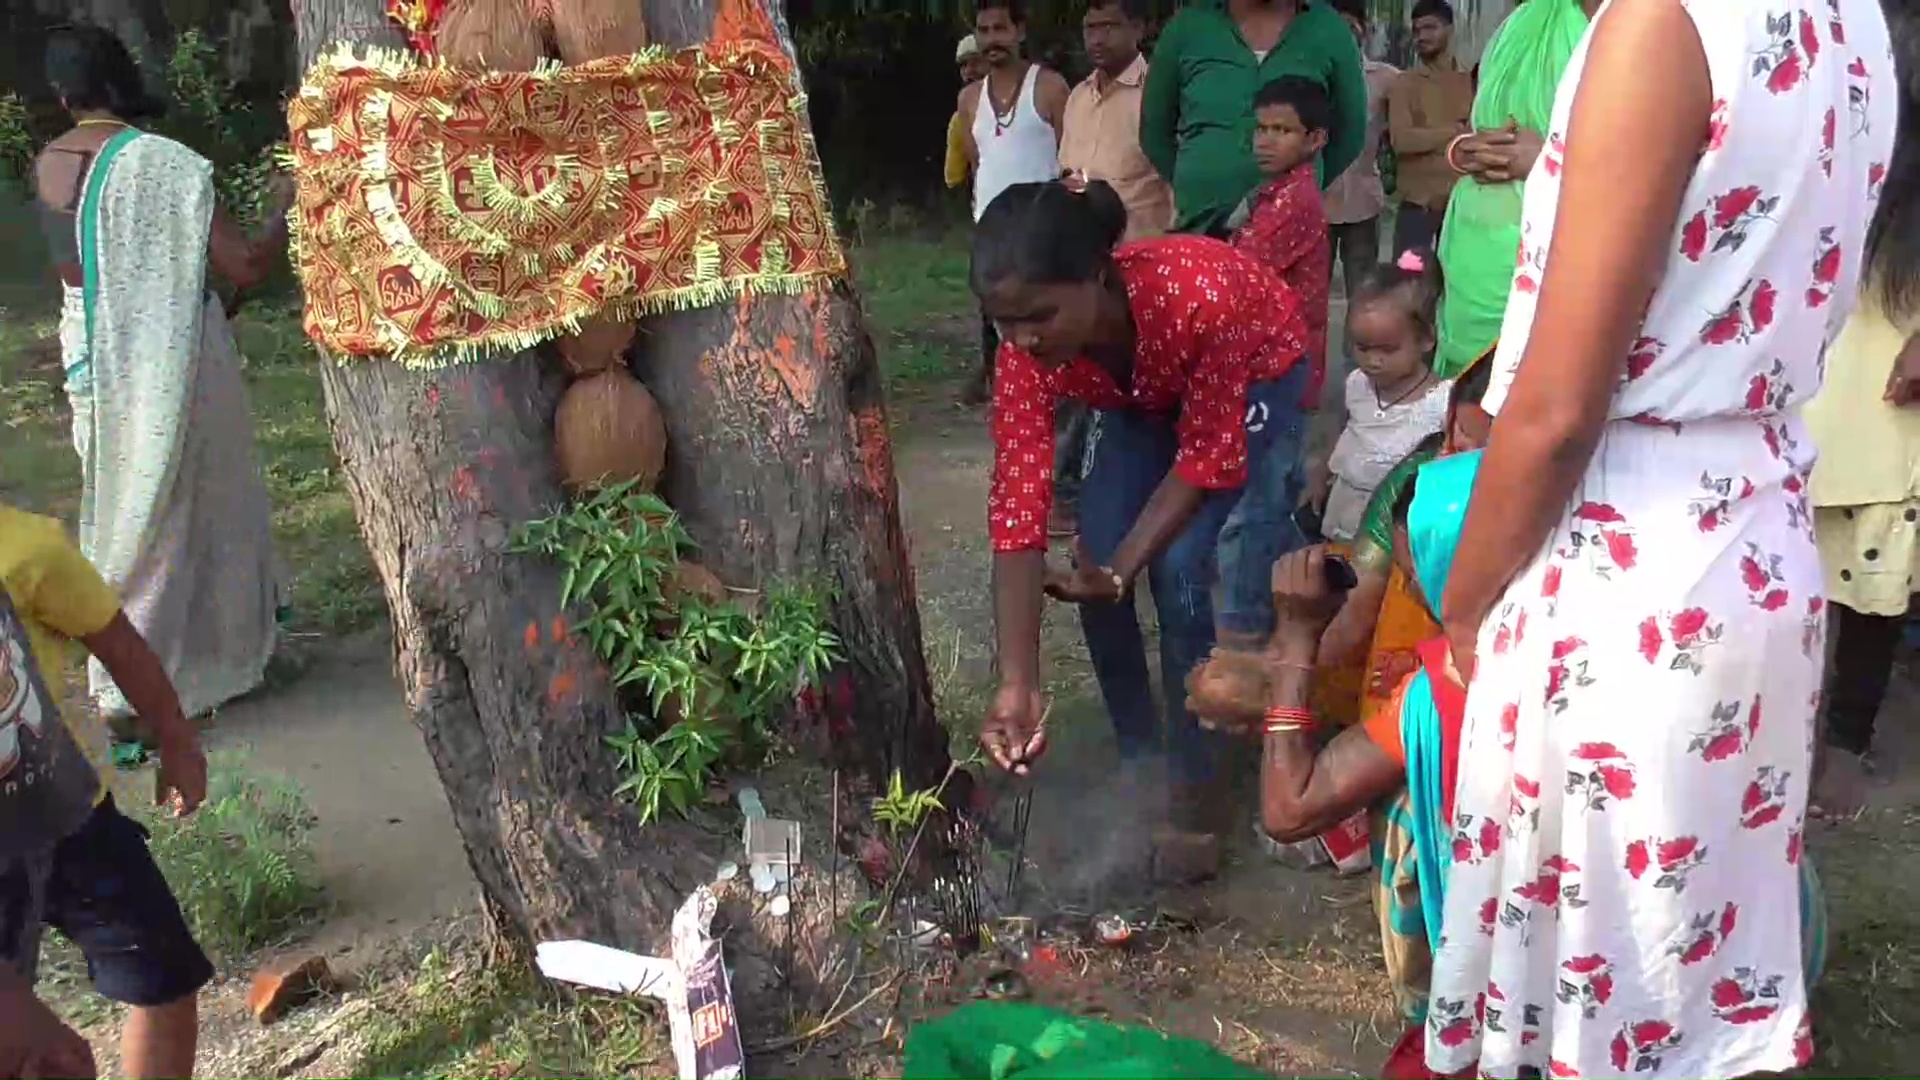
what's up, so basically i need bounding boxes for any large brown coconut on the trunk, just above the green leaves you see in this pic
[553,367,666,490]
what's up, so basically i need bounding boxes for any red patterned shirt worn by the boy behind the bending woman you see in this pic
[1233,161,1332,407]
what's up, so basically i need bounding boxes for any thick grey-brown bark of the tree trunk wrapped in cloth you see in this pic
[294,0,947,949]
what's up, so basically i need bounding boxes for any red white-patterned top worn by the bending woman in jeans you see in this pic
[987,236,1308,552]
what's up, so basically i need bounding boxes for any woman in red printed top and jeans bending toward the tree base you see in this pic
[972,174,1311,874]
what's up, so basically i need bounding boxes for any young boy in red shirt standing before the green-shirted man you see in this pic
[1227,75,1332,407]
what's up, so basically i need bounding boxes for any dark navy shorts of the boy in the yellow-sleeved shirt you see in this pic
[0,798,213,1005]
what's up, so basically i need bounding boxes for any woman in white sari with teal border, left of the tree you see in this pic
[35,27,288,721]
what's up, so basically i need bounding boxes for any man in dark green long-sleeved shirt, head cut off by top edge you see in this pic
[1140,0,1367,234]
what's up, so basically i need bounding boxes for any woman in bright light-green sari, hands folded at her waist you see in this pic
[1434,0,1599,379]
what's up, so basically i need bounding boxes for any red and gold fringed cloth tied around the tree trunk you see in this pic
[288,38,847,365]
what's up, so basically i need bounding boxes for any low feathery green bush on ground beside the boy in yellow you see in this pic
[138,755,321,957]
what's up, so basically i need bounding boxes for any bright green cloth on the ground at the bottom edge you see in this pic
[900,1001,1263,1080]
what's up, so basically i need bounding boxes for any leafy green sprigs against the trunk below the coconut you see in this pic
[515,484,839,821]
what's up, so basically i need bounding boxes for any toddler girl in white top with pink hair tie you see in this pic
[1308,252,1452,544]
